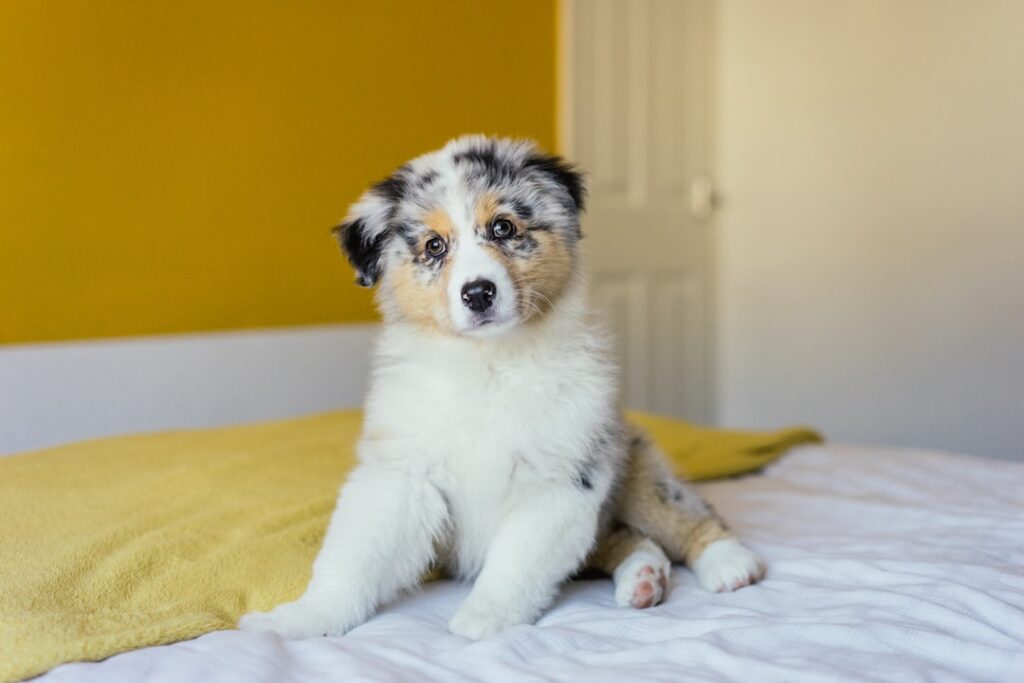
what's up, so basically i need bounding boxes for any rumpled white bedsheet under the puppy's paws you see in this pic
[43,445,1024,683]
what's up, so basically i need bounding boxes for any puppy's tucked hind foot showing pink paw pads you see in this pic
[587,526,672,609]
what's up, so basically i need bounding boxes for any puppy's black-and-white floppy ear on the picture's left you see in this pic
[334,173,406,287]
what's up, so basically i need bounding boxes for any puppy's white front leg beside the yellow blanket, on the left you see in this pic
[239,465,447,638]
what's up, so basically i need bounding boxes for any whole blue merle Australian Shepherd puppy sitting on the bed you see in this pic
[241,136,762,639]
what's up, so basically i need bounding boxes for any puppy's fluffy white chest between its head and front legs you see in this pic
[360,307,616,575]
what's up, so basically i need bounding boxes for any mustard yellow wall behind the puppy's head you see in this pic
[0,0,555,343]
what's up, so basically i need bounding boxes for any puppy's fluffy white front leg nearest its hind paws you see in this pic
[449,486,600,640]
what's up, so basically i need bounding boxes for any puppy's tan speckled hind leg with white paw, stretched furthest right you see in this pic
[613,429,764,592]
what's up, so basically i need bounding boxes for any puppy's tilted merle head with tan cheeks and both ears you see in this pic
[336,136,585,337]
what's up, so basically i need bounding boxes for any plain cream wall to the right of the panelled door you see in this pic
[716,0,1024,458]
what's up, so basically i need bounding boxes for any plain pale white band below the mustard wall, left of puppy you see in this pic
[0,325,377,455]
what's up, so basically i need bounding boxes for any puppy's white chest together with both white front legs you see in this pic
[242,274,616,638]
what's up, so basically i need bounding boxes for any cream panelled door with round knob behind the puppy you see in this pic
[560,0,713,421]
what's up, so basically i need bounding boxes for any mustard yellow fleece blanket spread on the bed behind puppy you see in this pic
[0,411,819,681]
